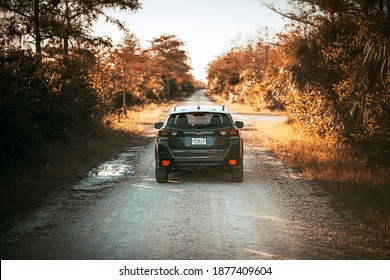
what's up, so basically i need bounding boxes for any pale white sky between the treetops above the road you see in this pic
[95,0,288,81]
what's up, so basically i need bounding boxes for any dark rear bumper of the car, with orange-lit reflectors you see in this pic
[156,139,243,170]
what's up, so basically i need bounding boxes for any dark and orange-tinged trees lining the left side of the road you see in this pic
[0,0,194,165]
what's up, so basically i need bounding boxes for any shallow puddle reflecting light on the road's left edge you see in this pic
[72,147,139,191]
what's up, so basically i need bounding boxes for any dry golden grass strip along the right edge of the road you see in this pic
[257,123,390,236]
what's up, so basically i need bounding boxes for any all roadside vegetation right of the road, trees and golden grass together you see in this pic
[207,0,390,235]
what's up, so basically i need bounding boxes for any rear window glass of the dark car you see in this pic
[167,112,232,129]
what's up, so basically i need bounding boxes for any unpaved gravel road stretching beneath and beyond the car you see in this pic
[0,92,390,259]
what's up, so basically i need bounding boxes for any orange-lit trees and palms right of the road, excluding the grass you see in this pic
[208,0,390,166]
